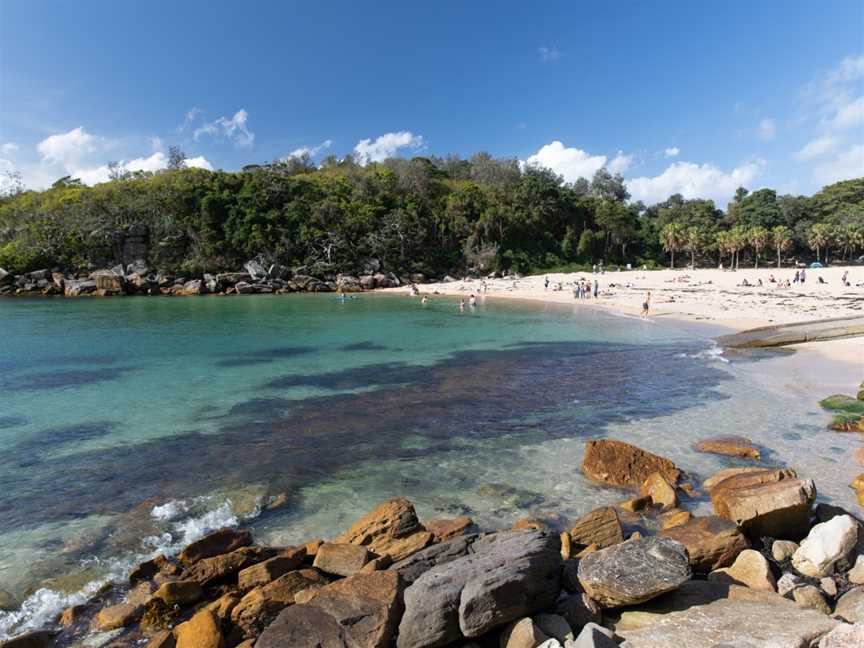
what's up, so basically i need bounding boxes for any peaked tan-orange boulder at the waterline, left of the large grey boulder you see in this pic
[334,499,432,562]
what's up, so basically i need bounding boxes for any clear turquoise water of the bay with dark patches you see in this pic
[0,295,857,638]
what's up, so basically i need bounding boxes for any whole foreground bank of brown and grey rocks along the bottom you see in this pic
[3,430,864,648]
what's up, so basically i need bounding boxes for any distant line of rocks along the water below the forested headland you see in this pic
[0,260,416,297]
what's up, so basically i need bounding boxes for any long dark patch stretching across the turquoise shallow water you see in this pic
[0,342,730,529]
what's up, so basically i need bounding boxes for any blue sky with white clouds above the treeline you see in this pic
[0,0,864,206]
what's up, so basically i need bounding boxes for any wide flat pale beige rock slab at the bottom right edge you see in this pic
[617,599,839,648]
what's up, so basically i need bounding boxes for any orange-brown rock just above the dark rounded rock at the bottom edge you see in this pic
[231,569,327,635]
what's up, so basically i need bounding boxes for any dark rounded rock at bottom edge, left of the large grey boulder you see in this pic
[255,605,351,648]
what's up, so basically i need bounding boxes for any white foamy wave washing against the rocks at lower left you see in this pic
[0,497,261,641]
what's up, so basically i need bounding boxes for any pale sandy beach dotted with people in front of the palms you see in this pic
[386,266,864,378]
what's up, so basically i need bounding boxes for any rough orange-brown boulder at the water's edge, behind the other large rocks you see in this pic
[582,439,681,488]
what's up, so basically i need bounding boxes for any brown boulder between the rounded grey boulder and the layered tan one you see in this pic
[658,515,750,574]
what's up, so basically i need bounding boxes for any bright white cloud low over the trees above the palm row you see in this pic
[627,160,765,208]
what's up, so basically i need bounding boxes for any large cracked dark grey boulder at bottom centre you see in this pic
[397,531,562,648]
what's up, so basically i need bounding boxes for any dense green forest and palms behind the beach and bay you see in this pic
[0,150,864,276]
